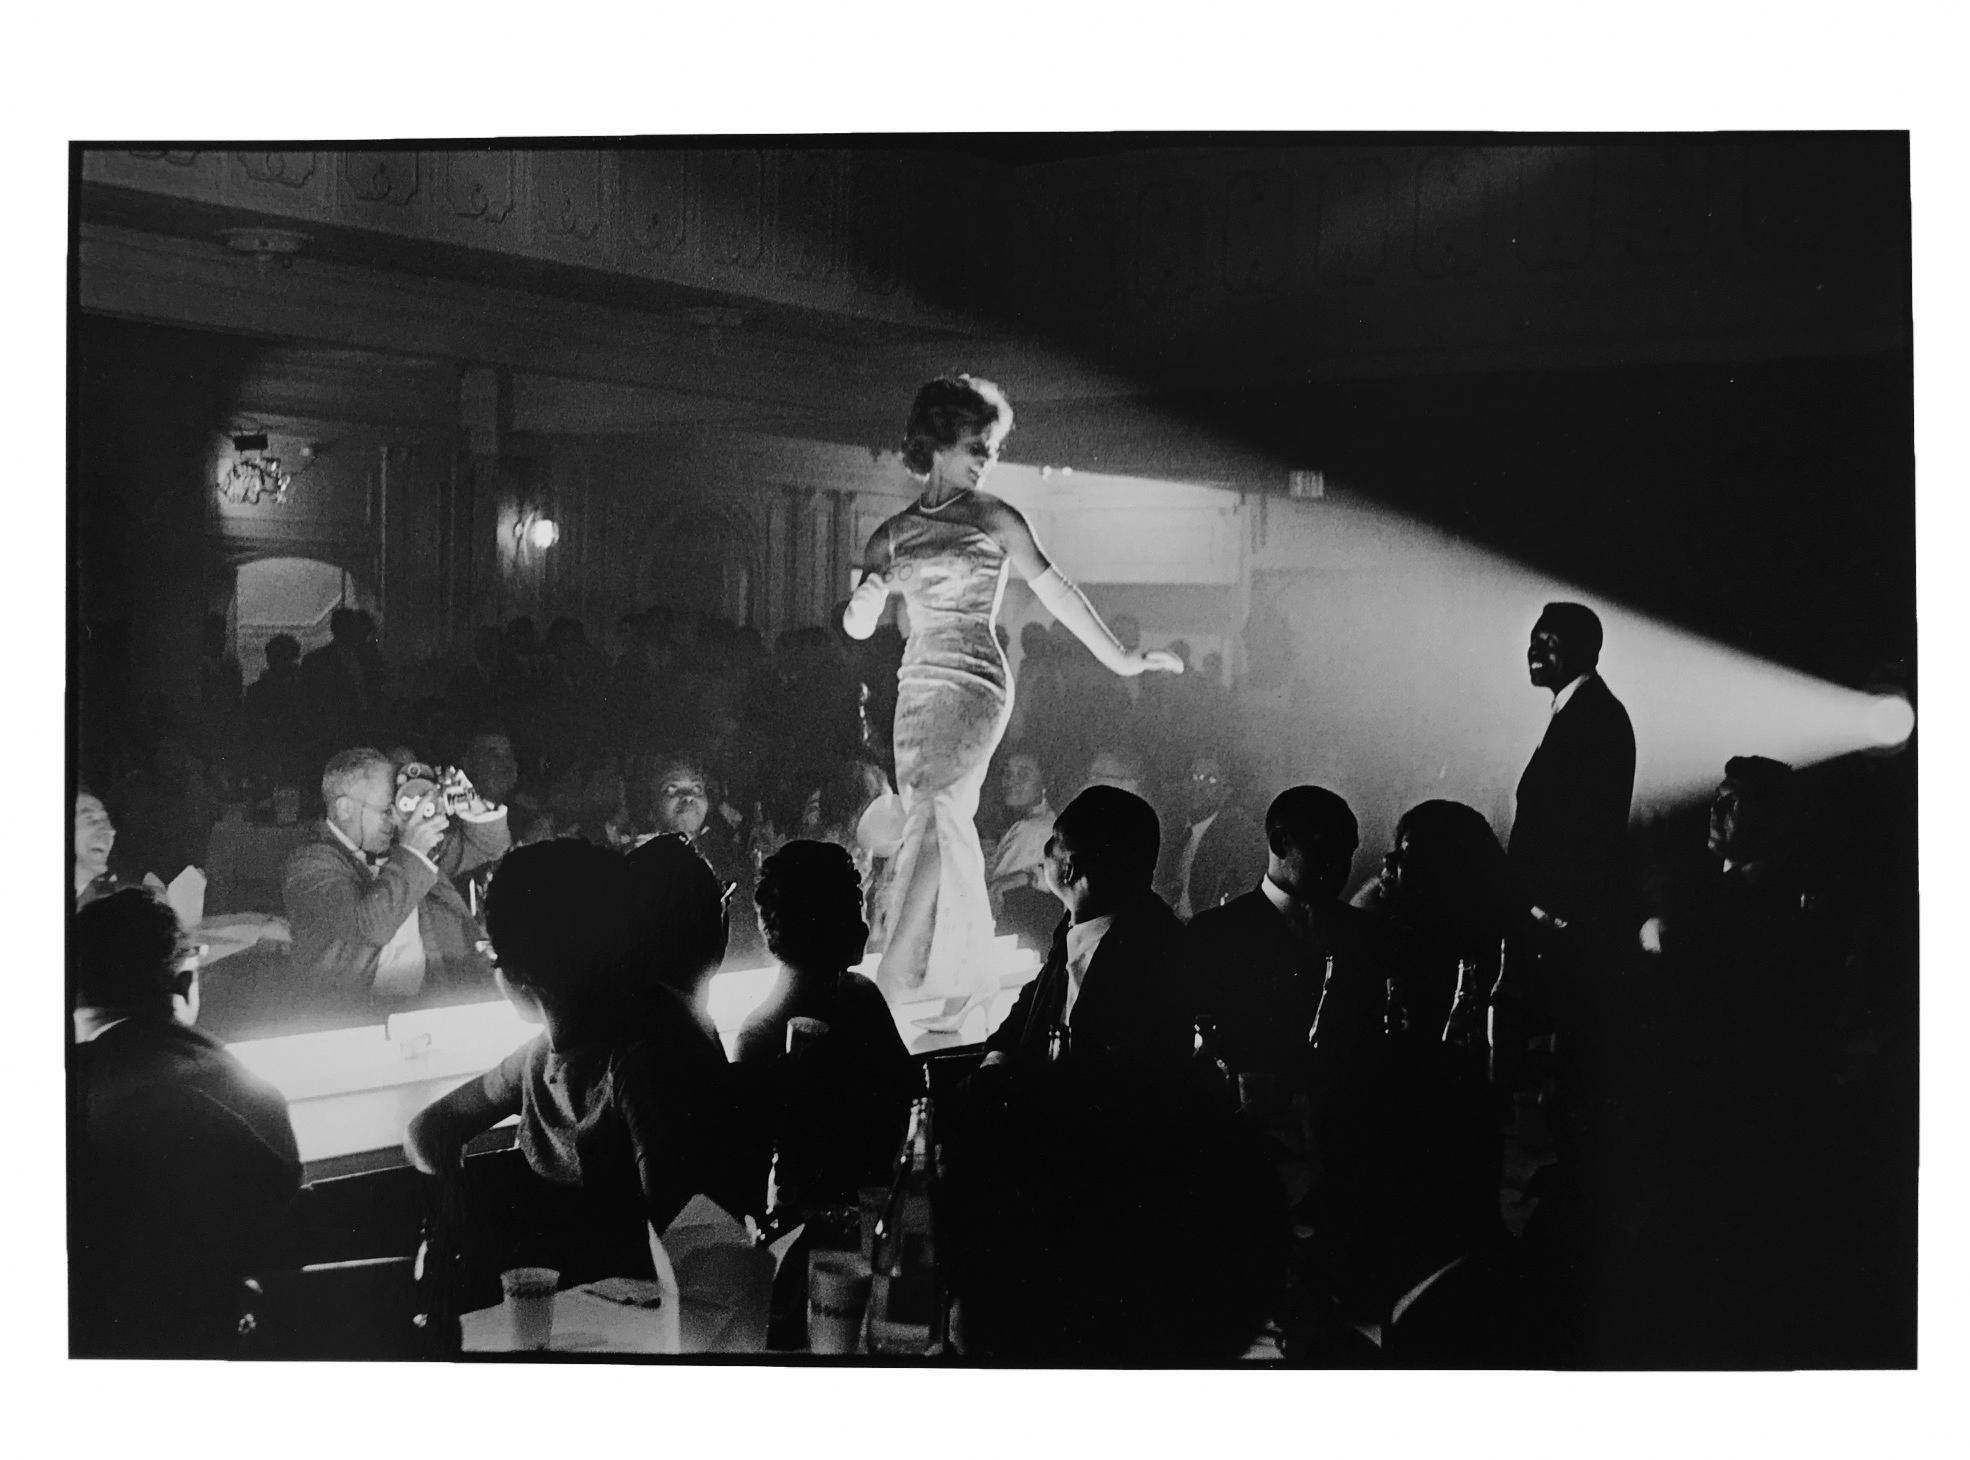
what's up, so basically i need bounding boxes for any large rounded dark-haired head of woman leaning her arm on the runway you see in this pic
[487,837,630,1007]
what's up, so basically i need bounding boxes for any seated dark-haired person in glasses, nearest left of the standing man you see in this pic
[1353,800,1513,1038]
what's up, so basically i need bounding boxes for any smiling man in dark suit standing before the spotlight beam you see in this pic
[1507,603,1635,936]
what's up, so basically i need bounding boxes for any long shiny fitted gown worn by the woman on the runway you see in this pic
[877,506,1013,999]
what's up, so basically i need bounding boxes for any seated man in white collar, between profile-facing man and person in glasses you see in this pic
[1188,786,1383,1080]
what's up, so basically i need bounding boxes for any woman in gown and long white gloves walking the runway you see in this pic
[841,374,1182,1027]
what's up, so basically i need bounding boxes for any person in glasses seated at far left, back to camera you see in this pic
[69,889,301,1358]
